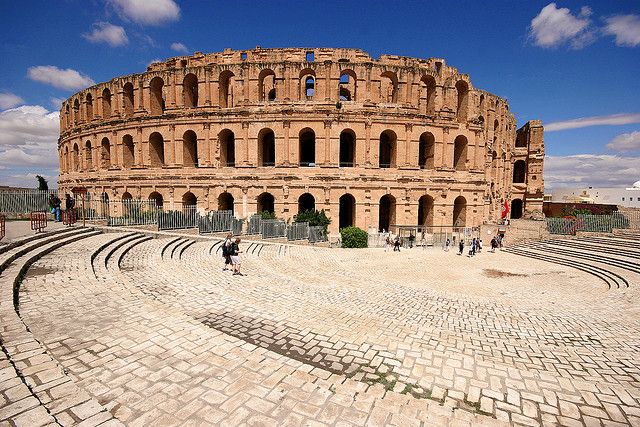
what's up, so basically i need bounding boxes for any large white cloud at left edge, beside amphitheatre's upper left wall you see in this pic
[0,105,60,148]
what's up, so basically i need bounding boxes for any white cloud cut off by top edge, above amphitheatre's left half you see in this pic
[107,0,180,25]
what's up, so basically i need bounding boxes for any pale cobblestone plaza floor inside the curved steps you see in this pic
[12,233,640,426]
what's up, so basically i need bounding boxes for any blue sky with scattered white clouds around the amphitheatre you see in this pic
[0,0,640,187]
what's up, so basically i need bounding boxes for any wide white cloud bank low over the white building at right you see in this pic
[544,154,640,189]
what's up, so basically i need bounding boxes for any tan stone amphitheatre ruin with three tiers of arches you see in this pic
[58,48,544,232]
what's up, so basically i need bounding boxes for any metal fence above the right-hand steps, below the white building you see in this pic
[545,212,640,235]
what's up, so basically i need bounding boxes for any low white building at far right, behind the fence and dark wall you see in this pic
[544,181,640,208]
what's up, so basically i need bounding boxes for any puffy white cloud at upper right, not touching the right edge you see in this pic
[529,3,595,49]
